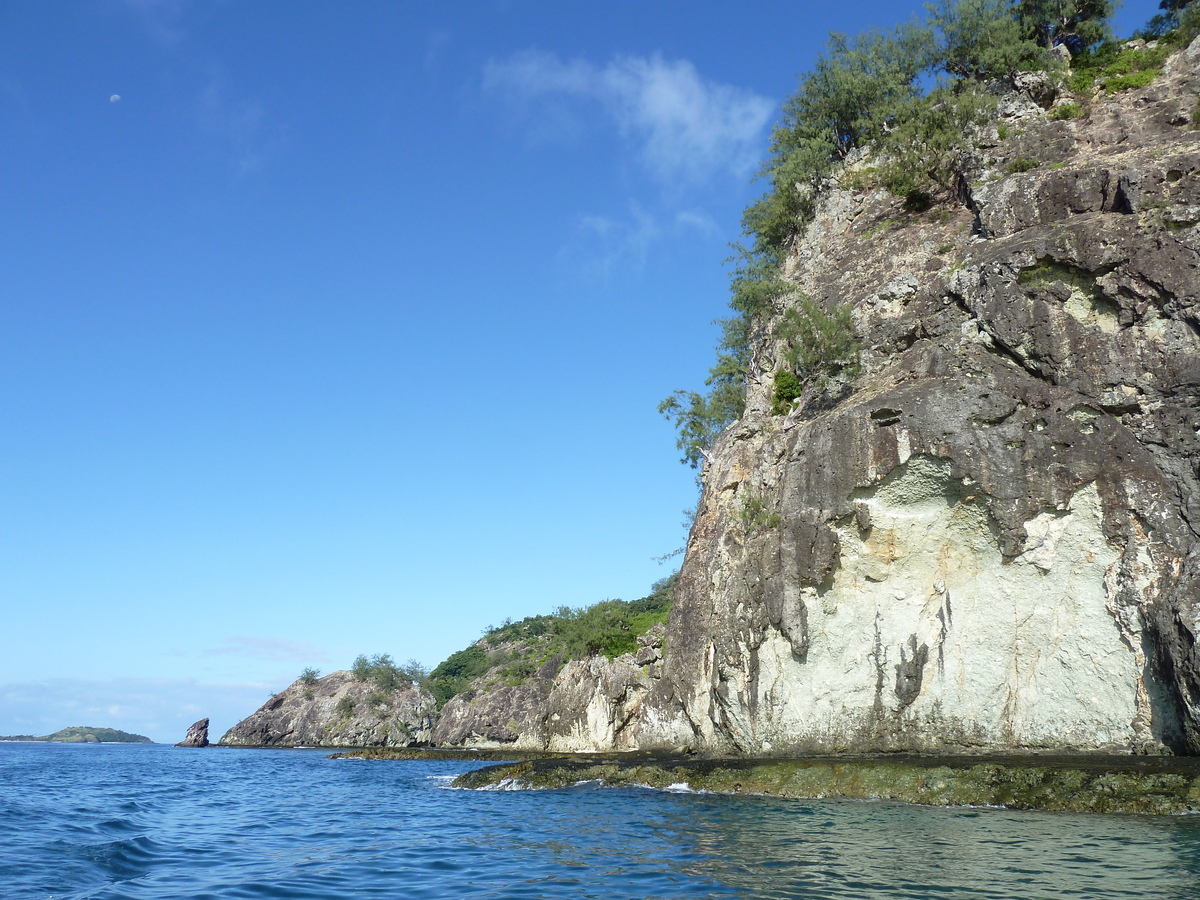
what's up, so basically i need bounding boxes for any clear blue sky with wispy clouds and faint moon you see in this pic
[0,0,1153,740]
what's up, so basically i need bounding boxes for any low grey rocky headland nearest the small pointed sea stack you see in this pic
[218,671,436,746]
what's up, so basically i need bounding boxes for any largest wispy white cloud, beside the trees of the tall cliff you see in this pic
[484,50,774,181]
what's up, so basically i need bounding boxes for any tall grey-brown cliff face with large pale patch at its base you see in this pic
[622,41,1200,754]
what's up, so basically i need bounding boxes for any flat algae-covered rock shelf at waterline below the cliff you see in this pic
[454,756,1200,815]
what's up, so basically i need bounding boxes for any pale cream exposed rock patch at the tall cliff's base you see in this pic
[720,456,1148,750]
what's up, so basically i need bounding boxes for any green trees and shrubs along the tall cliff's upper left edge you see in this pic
[659,0,1112,467]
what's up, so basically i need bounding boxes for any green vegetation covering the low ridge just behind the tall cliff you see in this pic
[426,575,678,709]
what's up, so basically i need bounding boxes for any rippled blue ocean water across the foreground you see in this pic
[0,744,1200,900]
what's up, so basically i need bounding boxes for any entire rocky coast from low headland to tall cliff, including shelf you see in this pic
[220,30,1200,814]
